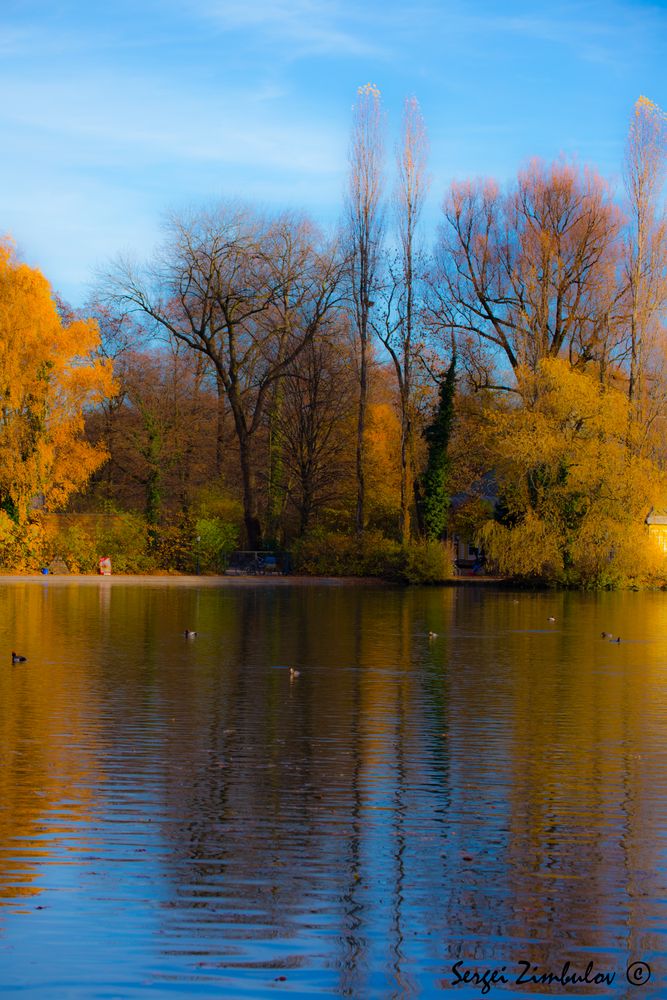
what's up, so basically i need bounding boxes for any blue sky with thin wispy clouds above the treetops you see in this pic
[0,0,667,305]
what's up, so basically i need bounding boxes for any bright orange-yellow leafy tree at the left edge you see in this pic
[0,241,115,525]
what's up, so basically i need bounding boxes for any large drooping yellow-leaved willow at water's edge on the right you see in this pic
[480,358,664,586]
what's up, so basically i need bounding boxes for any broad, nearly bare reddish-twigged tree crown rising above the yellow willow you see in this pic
[432,161,621,389]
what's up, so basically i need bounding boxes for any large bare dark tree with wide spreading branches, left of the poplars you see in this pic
[108,205,342,549]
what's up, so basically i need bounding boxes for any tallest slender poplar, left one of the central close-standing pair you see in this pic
[346,83,384,533]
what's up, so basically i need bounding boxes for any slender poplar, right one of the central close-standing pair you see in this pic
[373,98,428,544]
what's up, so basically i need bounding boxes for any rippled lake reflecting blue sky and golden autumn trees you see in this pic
[0,577,667,1000]
